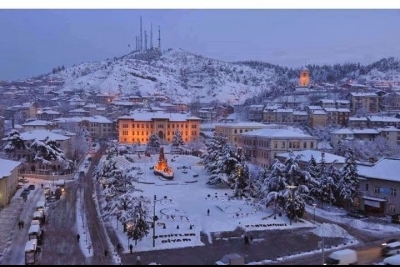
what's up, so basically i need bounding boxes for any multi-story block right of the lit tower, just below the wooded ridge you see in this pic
[347,93,379,114]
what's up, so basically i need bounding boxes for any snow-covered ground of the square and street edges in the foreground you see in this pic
[0,149,400,265]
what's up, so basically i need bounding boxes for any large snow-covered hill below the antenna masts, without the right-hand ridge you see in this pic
[49,50,276,104]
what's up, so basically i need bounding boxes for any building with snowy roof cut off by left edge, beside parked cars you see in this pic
[0,159,22,209]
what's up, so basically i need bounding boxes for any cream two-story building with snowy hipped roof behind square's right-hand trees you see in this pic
[238,129,318,168]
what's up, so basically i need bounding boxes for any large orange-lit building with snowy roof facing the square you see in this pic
[117,112,201,147]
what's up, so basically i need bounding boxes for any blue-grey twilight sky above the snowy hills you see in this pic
[0,9,400,80]
